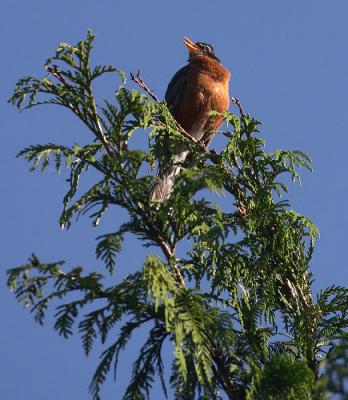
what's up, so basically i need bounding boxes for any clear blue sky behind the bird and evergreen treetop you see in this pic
[0,0,348,400]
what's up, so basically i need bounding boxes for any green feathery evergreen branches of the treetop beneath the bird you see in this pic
[8,32,348,400]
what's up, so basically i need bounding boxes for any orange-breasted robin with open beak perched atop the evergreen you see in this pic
[151,37,231,203]
